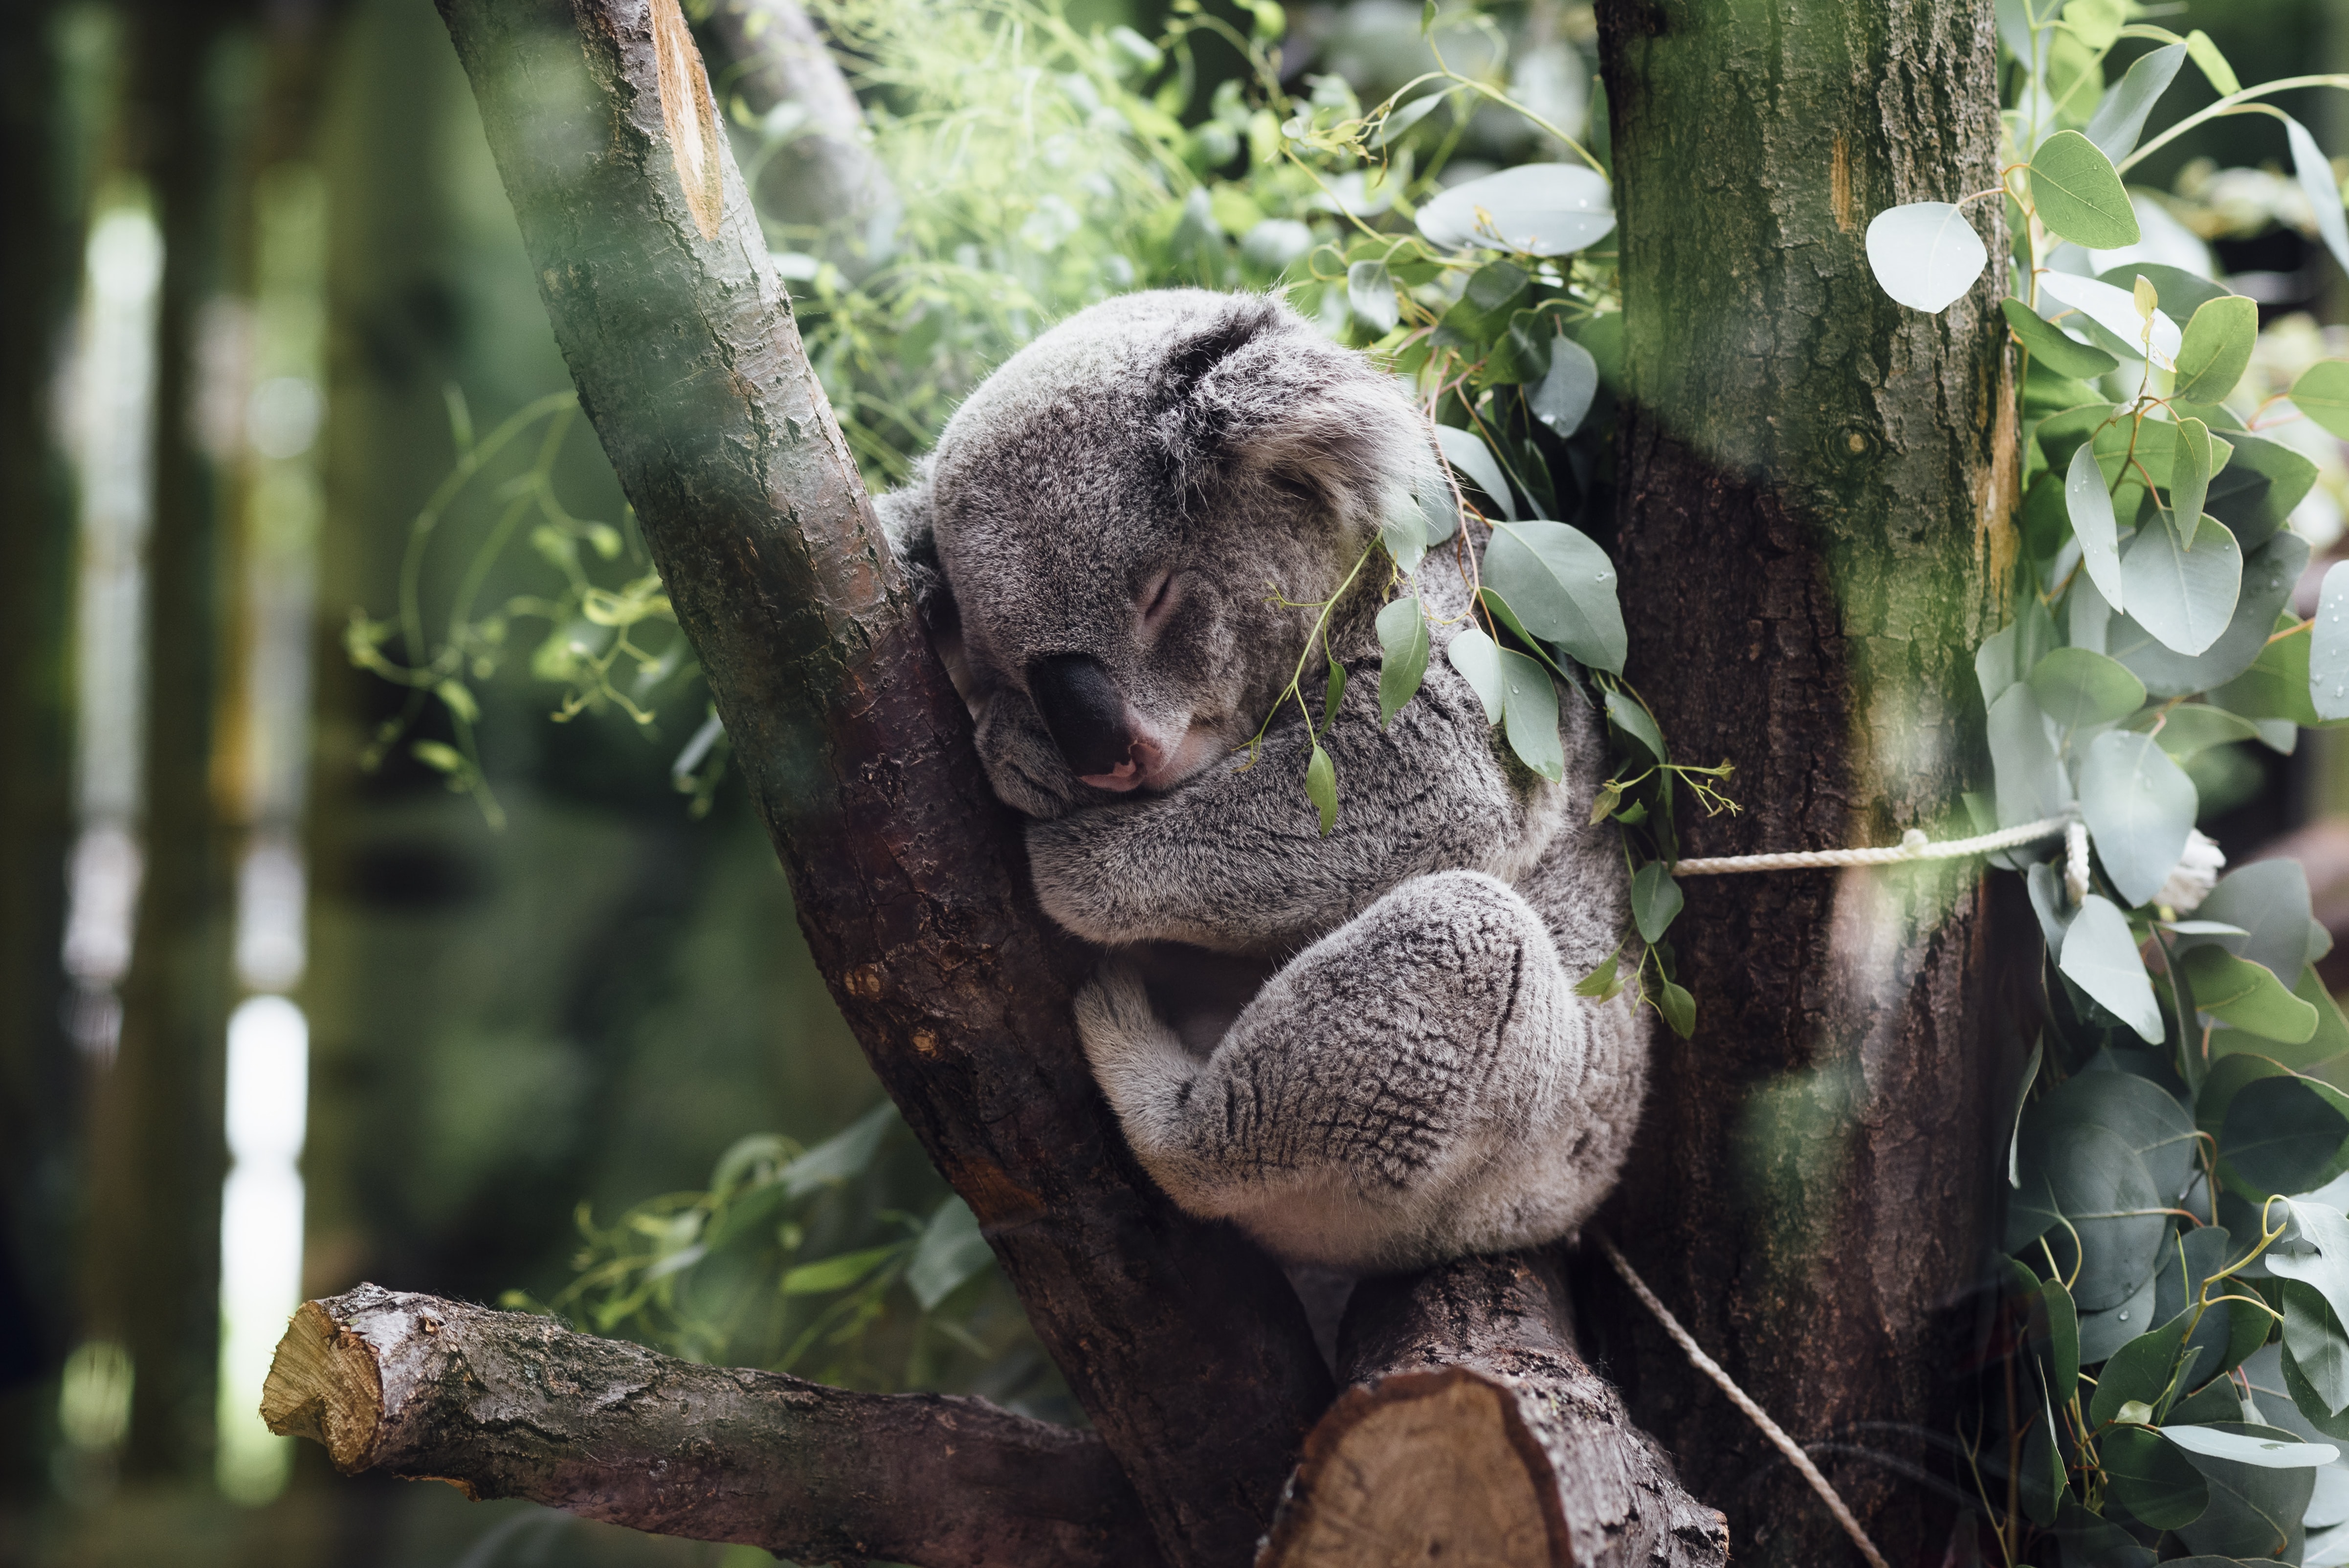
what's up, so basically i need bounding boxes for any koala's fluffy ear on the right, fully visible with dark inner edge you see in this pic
[1156,296,1440,540]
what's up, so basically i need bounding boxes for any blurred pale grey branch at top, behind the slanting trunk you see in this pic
[709,0,900,277]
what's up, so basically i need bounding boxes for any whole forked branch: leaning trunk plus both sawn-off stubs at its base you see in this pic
[268,0,1720,1568]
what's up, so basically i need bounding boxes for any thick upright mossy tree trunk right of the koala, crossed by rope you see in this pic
[1595,0,2013,1566]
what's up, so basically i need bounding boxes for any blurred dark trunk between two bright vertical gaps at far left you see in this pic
[82,0,230,1477]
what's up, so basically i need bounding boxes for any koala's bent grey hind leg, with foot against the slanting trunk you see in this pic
[1076,871,1597,1270]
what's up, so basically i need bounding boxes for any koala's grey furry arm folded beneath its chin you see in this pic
[1029,653,1590,953]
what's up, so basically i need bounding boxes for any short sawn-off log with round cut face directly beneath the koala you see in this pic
[1259,1254,1729,1568]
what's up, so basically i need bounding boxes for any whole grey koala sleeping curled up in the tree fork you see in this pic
[881,289,1647,1272]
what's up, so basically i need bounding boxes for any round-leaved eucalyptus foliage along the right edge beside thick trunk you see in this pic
[1870,15,2349,1568]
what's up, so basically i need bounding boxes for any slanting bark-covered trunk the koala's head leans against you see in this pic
[439,0,1330,1566]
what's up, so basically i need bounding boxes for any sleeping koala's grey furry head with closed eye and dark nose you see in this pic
[930,291,1423,817]
